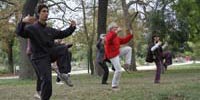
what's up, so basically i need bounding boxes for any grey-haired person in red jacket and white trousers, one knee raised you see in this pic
[104,22,133,89]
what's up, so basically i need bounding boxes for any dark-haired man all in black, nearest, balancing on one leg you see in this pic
[16,4,76,100]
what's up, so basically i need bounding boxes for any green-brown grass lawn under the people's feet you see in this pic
[0,64,200,100]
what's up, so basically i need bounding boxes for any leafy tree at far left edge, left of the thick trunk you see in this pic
[0,0,20,73]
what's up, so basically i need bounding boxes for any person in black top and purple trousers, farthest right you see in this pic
[147,34,172,83]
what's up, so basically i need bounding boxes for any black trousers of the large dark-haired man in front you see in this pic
[31,45,71,100]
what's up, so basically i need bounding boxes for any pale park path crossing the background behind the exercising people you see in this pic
[0,61,200,79]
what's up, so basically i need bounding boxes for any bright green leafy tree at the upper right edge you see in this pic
[173,0,200,58]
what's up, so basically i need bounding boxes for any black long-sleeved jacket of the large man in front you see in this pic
[16,22,76,59]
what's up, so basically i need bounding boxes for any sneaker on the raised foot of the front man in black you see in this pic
[60,73,73,87]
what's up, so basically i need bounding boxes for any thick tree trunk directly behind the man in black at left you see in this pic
[19,0,38,79]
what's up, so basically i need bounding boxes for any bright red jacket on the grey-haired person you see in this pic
[104,31,133,59]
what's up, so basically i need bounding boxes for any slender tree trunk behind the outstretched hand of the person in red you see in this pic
[121,0,137,71]
